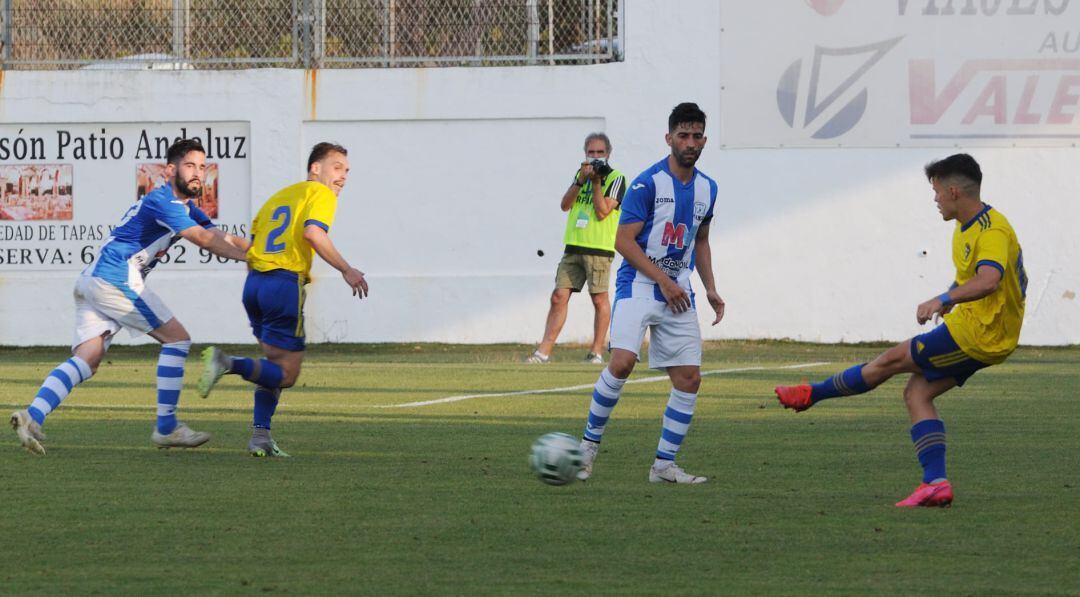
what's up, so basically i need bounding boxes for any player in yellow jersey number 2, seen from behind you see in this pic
[199,143,367,457]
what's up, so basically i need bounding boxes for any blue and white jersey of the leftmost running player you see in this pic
[89,185,214,284]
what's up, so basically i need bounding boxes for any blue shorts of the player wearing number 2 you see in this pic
[244,270,305,352]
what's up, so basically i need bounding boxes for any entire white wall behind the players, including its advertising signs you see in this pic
[0,0,1080,344]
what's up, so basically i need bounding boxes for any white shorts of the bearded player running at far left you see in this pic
[71,275,173,349]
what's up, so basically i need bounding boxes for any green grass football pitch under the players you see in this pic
[0,342,1080,595]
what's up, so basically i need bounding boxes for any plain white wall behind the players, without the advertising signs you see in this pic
[0,0,1080,344]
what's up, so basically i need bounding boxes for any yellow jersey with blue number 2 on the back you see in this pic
[247,180,337,282]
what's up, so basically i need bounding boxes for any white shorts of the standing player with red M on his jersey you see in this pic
[610,297,701,369]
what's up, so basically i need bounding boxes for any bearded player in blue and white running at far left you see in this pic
[11,139,249,454]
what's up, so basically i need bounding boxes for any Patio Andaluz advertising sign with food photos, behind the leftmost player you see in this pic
[0,122,251,271]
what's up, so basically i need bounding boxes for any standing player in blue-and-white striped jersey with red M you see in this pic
[578,103,724,484]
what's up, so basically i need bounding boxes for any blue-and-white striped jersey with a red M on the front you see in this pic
[615,158,716,301]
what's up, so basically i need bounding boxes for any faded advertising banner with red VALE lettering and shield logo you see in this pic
[720,0,1080,147]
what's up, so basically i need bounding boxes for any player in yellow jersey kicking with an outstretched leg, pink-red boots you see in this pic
[775,153,1027,507]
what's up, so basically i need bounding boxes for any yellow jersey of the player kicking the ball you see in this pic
[945,205,1027,365]
